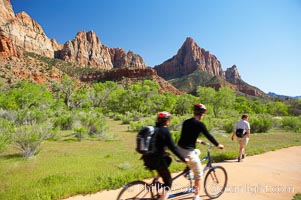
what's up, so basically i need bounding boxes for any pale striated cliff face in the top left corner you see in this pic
[0,0,62,57]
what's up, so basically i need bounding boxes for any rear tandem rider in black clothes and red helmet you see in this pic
[142,112,187,200]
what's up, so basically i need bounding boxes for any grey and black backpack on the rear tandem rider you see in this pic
[136,126,157,155]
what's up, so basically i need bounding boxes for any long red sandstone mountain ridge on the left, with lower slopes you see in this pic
[0,0,181,94]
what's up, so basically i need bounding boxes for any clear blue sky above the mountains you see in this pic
[11,0,301,96]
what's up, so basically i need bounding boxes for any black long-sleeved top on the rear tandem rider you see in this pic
[155,126,185,162]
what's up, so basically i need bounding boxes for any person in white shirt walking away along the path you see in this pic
[231,114,251,162]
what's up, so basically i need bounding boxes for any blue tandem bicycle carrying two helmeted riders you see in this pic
[117,141,228,200]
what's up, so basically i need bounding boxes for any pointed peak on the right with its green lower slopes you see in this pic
[154,37,265,96]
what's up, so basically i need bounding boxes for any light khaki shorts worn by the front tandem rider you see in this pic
[179,147,203,180]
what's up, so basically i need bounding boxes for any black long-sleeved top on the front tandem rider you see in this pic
[178,117,218,150]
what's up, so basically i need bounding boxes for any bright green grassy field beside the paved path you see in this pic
[0,120,301,200]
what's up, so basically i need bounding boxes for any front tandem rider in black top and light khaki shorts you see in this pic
[178,104,224,200]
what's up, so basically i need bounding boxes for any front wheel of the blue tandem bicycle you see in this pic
[204,166,228,199]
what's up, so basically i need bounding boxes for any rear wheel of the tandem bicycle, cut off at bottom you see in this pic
[117,181,153,200]
